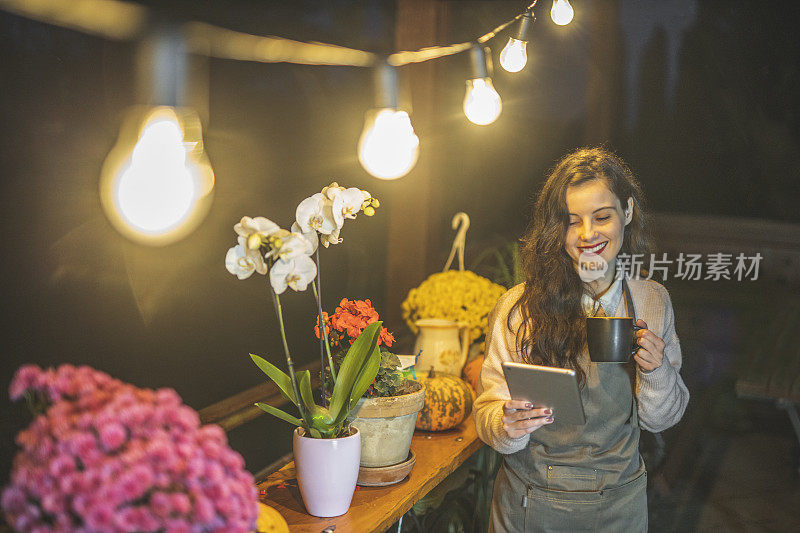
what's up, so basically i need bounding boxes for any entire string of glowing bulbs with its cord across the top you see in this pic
[6,0,574,214]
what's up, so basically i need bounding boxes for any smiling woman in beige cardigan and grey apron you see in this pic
[475,148,689,532]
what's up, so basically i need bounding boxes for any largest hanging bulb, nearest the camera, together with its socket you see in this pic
[100,28,214,245]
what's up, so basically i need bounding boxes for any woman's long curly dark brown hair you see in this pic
[507,148,651,385]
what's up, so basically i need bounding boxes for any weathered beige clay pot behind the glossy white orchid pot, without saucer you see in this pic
[352,382,425,468]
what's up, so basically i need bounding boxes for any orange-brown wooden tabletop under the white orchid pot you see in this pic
[259,416,483,533]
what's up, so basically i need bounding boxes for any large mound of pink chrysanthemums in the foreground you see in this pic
[0,365,258,533]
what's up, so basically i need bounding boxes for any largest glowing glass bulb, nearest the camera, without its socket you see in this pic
[100,107,214,244]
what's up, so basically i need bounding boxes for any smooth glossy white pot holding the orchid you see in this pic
[292,428,361,517]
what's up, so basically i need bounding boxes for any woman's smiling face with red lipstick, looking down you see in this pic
[564,179,633,291]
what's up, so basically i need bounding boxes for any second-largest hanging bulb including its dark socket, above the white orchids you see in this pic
[358,62,419,180]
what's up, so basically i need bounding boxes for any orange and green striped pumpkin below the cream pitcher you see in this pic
[416,367,474,431]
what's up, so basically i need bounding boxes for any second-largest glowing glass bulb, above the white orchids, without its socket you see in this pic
[358,108,419,180]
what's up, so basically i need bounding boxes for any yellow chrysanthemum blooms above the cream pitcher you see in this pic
[402,270,506,341]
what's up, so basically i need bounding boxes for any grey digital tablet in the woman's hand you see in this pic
[503,362,586,425]
